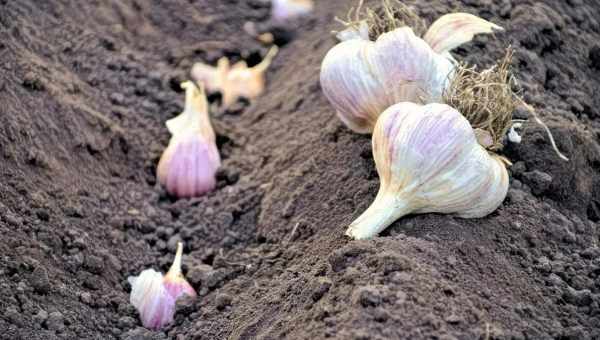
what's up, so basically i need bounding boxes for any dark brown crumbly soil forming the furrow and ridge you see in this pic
[0,0,600,340]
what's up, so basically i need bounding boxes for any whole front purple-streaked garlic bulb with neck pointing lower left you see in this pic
[346,102,508,239]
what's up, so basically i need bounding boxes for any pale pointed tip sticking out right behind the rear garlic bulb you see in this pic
[423,13,504,54]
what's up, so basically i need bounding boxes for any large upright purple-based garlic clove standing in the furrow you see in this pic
[157,82,221,197]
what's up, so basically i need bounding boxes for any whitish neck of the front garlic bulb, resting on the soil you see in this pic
[346,190,413,240]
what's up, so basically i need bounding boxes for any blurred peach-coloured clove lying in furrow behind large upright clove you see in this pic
[190,46,278,107]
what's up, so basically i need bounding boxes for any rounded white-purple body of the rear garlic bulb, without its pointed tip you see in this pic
[320,27,454,133]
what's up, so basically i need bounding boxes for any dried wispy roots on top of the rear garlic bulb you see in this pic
[336,0,427,40]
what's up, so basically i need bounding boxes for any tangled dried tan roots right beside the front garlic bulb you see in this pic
[443,48,519,151]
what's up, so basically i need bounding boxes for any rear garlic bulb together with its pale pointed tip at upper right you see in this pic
[320,13,502,133]
